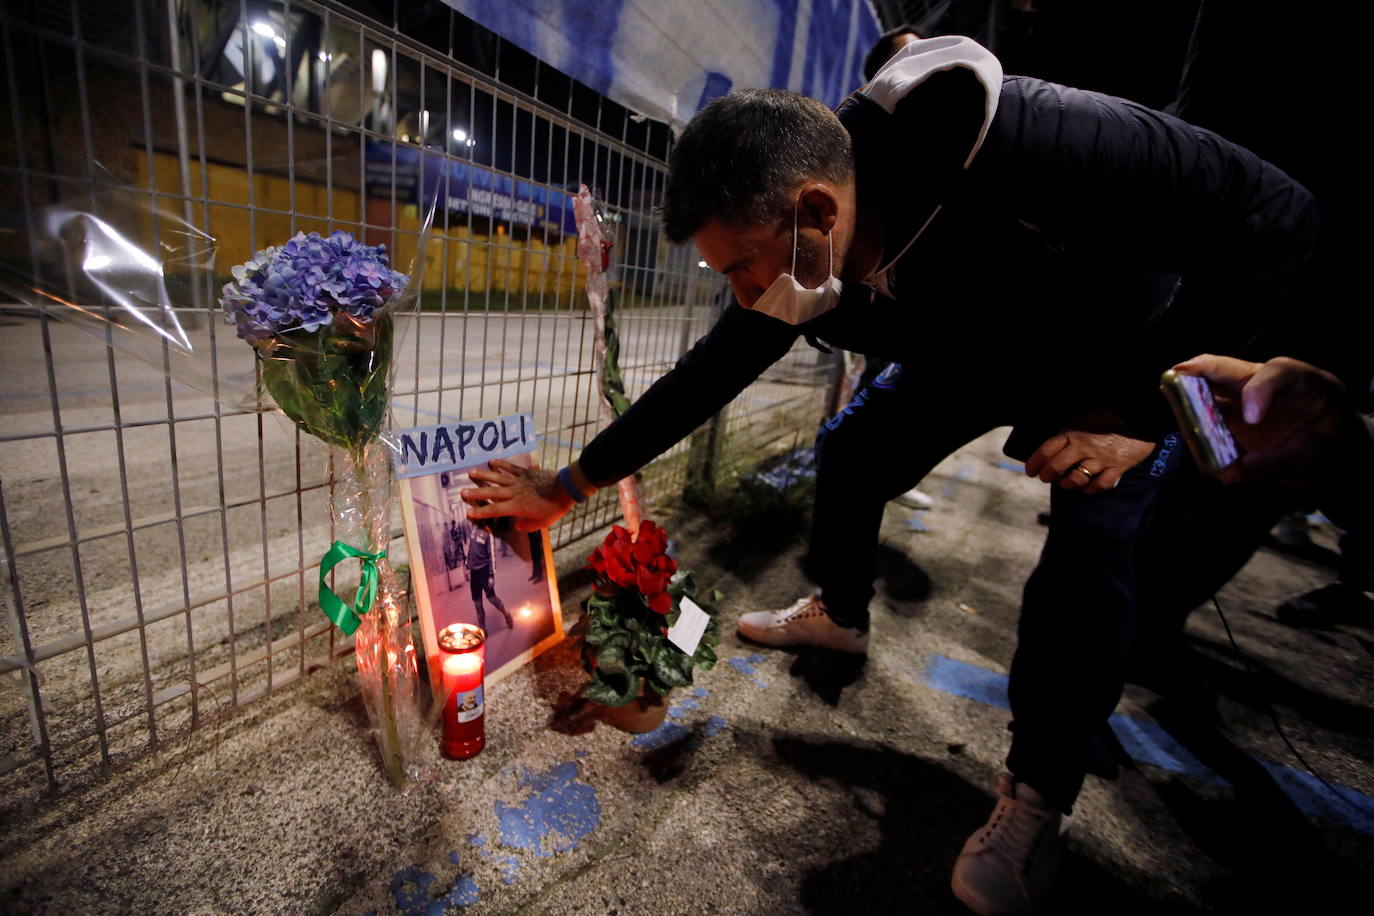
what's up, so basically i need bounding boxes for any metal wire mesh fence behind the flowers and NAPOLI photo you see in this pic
[0,0,829,794]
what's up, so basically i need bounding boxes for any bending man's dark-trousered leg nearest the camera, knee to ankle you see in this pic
[1007,435,1183,812]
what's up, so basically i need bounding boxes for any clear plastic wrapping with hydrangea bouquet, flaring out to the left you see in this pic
[0,155,434,787]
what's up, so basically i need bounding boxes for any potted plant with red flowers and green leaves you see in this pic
[583,519,720,732]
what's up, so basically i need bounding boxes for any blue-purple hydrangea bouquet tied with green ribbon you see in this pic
[220,232,426,786]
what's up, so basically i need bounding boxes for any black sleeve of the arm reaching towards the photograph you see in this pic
[578,304,797,486]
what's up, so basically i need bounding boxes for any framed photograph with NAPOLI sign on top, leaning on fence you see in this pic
[387,413,563,684]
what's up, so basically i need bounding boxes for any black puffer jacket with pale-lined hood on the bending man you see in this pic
[581,38,1316,485]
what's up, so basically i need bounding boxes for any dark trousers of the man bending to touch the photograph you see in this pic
[807,369,1186,808]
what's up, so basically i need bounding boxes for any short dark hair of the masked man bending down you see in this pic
[661,89,853,243]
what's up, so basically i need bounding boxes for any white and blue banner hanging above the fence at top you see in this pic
[445,0,881,130]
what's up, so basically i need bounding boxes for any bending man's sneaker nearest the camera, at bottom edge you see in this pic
[951,773,1069,916]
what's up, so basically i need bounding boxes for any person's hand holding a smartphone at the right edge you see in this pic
[1173,354,1369,485]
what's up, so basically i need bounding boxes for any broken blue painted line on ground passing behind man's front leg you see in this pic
[921,655,1374,836]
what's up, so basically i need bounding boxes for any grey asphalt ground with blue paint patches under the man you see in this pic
[0,433,1374,916]
